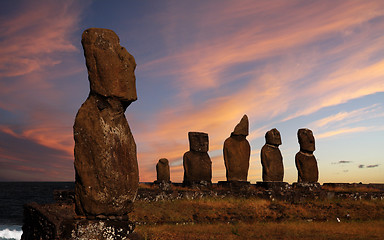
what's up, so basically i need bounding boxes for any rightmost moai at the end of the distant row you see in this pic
[295,128,319,183]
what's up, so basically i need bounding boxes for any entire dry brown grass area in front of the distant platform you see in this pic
[130,186,384,240]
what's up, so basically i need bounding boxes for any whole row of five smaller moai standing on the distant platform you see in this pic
[155,115,319,185]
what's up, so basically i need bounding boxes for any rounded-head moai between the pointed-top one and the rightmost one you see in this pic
[260,128,284,182]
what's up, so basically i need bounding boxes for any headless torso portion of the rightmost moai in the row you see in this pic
[295,151,319,183]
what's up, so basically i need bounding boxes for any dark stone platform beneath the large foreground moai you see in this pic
[21,203,143,240]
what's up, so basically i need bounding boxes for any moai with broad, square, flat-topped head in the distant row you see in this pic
[183,132,212,185]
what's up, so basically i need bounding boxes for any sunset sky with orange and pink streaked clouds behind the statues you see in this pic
[0,0,384,183]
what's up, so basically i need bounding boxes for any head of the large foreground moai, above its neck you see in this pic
[81,28,137,105]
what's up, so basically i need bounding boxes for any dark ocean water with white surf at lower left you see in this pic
[0,182,75,240]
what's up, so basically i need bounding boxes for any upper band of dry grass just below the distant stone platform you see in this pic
[130,198,384,224]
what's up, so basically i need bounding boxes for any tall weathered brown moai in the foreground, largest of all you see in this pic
[73,28,139,216]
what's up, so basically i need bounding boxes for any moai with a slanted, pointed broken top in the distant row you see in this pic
[223,115,251,181]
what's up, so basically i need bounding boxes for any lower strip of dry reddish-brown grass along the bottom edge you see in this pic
[136,221,384,240]
